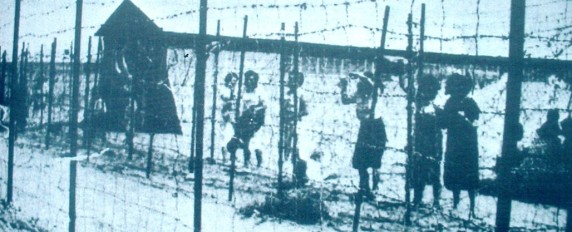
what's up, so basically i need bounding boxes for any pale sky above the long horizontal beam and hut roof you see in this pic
[0,0,572,59]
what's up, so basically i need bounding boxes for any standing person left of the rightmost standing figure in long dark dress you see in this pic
[411,76,443,207]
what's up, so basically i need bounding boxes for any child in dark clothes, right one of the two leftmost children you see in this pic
[226,70,266,167]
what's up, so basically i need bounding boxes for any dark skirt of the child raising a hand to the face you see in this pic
[352,118,387,170]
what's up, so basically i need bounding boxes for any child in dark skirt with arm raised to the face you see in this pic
[340,72,387,200]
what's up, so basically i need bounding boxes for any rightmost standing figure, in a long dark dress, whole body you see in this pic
[440,73,481,216]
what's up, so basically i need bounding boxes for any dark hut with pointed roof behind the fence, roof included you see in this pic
[93,0,182,134]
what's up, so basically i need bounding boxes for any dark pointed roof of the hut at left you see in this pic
[95,0,162,36]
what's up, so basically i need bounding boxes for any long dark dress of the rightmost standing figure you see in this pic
[440,97,480,190]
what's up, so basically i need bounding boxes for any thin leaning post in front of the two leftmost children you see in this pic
[228,15,248,201]
